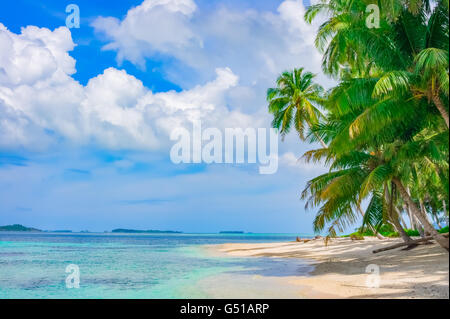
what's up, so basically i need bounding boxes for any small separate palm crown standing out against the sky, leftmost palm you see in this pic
[267,68,327,148]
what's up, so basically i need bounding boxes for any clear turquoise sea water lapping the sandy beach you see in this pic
[0,232,307,299]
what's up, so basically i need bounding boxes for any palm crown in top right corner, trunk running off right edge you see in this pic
[374,5,449,128]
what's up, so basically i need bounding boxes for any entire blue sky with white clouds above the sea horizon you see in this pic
[0,0,342,233]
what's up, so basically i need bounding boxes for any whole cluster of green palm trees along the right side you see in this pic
[267,0,449,251]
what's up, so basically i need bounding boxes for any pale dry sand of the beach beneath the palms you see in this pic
[210,237,449,299]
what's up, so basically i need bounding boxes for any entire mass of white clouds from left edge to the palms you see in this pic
[0,0,330,154]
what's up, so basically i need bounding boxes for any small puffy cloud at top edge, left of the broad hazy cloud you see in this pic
[93,0,197,65]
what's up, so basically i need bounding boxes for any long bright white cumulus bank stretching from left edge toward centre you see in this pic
[0,23,255,150]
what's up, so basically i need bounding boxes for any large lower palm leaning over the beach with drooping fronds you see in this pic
[302,74,448,249]
